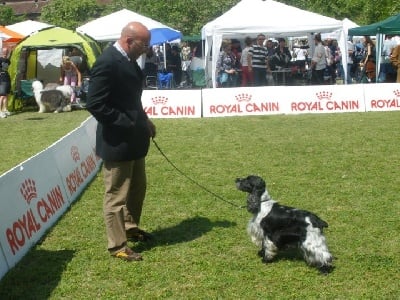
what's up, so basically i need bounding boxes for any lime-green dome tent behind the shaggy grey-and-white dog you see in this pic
[8,27,101,111]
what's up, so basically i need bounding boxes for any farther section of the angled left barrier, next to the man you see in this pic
[49,126,101,202]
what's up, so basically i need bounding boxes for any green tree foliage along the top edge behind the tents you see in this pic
[28,0,400,35]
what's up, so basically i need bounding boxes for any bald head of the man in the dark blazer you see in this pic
[118,22,151,60]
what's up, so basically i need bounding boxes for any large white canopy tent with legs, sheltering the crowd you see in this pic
[201,0,347,87]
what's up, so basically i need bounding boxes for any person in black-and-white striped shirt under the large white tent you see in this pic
[247,33,268,86]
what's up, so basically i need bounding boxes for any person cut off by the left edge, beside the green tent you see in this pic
[0,47,11,119]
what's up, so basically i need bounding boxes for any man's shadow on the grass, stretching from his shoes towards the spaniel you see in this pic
[134,216,236,252]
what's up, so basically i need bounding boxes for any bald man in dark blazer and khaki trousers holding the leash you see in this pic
[86,22,156,261]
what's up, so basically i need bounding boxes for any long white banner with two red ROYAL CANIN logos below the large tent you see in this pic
[203,85,374,117]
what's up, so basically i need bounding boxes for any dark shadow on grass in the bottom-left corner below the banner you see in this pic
[0,250,75,299]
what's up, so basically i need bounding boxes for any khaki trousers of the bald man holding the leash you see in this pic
[103,158,146,252]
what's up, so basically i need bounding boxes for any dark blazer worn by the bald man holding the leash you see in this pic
[86,46,150,161]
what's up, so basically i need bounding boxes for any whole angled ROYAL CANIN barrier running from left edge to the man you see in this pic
[0,118,101,278]
